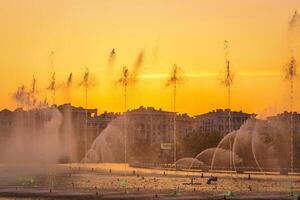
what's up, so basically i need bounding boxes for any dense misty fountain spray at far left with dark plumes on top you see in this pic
[0,63,76,189]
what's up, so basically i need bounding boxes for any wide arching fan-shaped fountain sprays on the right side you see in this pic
[181,118,291,172]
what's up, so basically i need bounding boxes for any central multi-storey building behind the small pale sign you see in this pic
[126,106,193,161]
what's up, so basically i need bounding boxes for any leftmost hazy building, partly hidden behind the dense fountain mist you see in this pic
[0,104,119,162]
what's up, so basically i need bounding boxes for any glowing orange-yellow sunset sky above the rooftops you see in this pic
[0,0,300,116]
